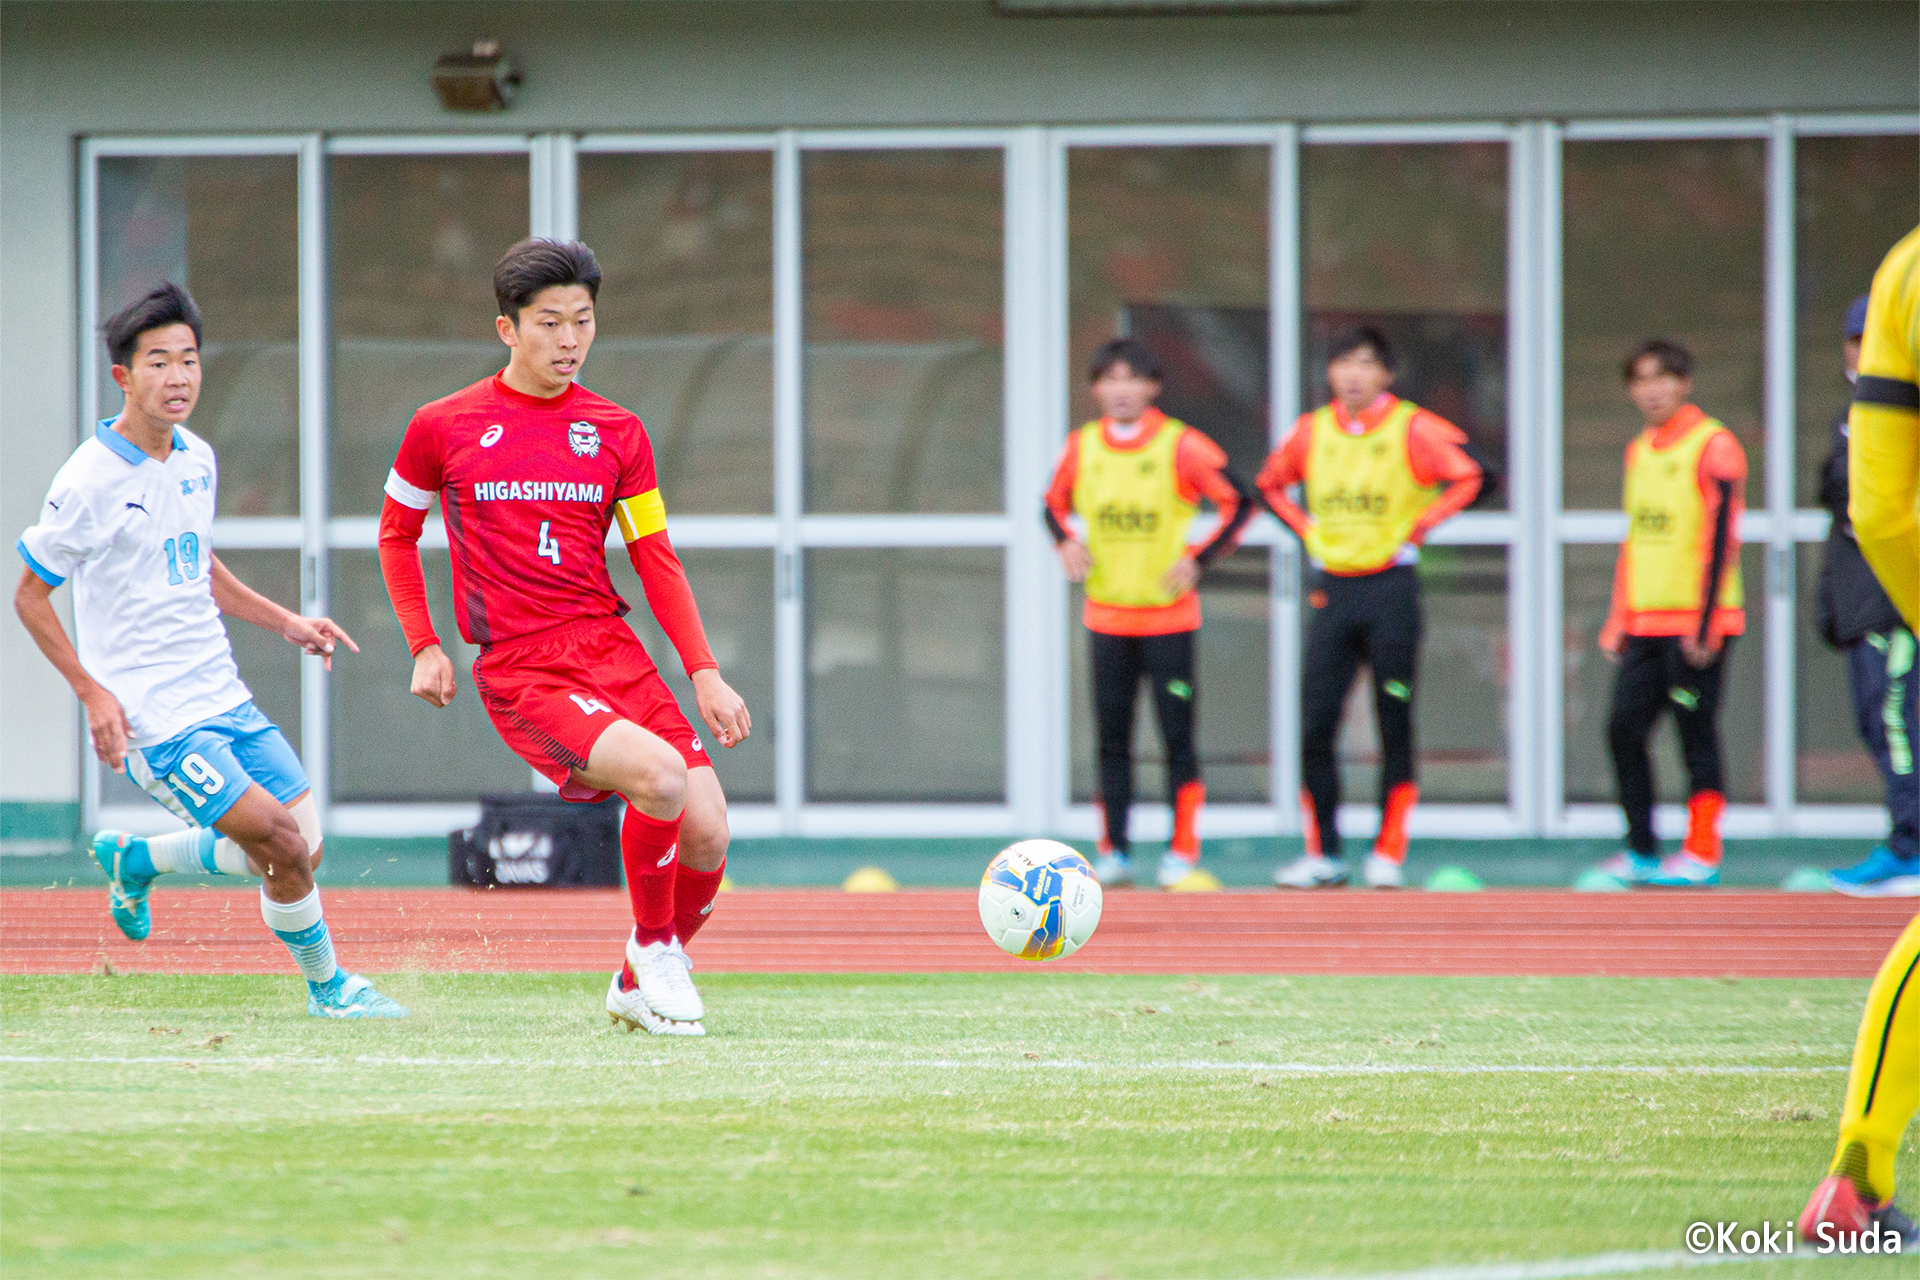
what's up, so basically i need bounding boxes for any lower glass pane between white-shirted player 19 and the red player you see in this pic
[326,551,532,804]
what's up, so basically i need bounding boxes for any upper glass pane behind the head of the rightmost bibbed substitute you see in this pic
[1561,138,1766,509]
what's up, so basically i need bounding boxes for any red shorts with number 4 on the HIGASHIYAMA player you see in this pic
[474,618,712,802]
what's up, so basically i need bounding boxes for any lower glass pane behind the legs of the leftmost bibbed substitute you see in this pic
[1071,547,1273,804]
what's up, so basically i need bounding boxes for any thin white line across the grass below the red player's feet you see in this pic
[0,1050,1847,1077]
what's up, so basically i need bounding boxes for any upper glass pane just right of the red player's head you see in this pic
[580,152,774,518]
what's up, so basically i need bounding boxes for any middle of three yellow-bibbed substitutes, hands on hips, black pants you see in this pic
[1258,328,1482,889]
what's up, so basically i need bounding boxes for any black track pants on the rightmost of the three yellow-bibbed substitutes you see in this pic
[1607,635,1734,854]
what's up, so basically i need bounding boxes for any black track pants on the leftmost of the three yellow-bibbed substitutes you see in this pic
[1091,631,1200,854]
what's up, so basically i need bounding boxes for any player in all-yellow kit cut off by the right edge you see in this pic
[1799,228,1920,1251]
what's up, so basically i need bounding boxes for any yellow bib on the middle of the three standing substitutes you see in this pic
[1304,401,1440,574]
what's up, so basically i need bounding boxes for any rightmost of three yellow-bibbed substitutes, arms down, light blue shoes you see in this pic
[1599,338,1747,887]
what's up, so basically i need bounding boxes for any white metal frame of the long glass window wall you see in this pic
[77,113,1920,839]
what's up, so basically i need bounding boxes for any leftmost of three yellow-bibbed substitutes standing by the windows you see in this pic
[1046,338,1254,889]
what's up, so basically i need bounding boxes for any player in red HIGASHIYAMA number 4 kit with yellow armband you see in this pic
[380,240,751,1036]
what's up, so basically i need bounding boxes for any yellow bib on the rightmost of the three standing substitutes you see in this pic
[1620,418,1741,614]
